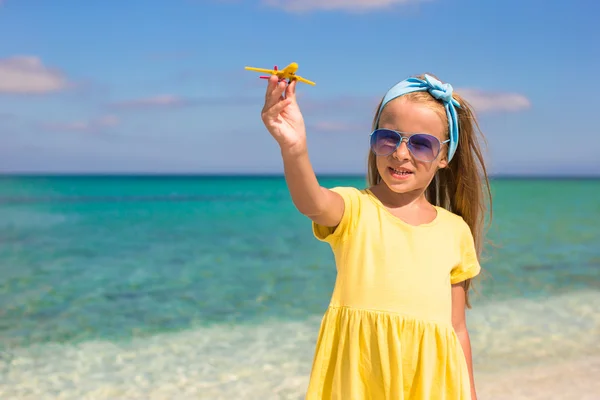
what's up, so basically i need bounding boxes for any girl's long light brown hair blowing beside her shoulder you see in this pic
[367,74,492,308]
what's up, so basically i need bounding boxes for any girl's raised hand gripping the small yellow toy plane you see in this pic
[262,75,306,152]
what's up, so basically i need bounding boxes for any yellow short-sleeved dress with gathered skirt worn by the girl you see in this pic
[306,187,480,400]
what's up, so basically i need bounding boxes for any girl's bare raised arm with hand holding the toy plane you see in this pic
[262,76,344,227]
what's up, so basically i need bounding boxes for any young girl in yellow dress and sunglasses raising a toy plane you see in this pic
[262,75,490,400]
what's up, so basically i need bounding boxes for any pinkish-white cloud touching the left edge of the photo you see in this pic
[0,55,68,94]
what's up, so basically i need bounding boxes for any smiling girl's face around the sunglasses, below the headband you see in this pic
[376,97,448,193]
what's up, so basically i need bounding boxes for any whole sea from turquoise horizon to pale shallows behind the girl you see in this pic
[0,176,600,400]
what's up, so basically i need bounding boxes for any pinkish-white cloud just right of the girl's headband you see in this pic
[457,88,531,112]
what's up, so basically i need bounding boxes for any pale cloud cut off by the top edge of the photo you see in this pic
[263,0,431,12]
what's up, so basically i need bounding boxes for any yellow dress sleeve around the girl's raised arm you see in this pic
[312,186,360,244]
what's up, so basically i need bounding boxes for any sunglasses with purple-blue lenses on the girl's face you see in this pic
[370,129,450,162]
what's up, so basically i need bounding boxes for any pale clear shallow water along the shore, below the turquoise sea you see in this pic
[0,291,600,399]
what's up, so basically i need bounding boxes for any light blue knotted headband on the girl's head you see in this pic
[375,75,460,162]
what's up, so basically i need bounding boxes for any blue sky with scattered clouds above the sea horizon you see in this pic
[0,0,600,176]
